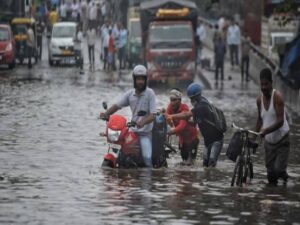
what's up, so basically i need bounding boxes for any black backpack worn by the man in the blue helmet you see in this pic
[201,98,227,133]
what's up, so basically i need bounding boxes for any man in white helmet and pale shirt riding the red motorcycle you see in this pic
[100,65,157,167]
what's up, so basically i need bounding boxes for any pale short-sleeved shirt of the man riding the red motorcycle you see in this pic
[117,87,157,134]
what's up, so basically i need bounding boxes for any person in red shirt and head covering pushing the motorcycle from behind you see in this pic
[167,89,199,165]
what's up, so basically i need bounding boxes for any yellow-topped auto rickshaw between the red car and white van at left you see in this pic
[11,17,38,64]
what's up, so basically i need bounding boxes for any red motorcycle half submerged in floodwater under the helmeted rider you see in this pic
[101,102,176,168]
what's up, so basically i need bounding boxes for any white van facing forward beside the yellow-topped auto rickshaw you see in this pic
[48,22,77,66]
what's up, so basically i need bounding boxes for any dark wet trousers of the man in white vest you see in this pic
[264,134,290,184]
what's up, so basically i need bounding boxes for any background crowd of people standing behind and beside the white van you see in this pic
[28,0,128,71]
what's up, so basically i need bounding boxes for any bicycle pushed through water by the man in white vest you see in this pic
[231,123,259,187]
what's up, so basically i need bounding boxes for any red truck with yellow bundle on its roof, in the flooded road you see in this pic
[140,0,198,83]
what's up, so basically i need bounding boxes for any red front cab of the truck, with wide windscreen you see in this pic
[146,21,196,81]
